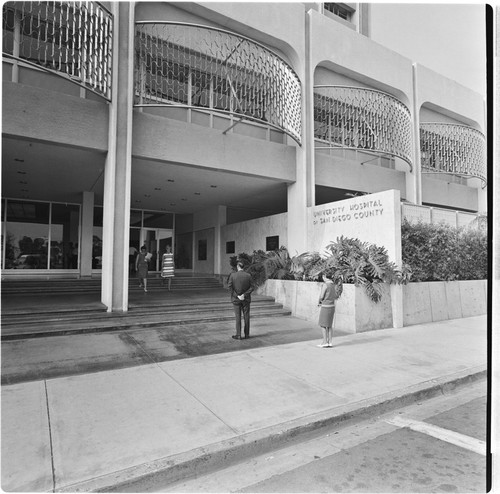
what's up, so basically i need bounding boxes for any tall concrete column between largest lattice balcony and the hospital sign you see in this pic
[287,13,316,256]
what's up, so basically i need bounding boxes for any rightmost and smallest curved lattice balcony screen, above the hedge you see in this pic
[420,123,486,186]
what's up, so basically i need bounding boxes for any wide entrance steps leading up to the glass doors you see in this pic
[2,277,291,341]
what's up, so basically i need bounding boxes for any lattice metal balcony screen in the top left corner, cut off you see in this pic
[3,2,113,100]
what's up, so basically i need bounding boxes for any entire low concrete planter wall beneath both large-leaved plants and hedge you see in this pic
[258,280,487,333]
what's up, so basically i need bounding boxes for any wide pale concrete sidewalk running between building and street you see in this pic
[2,316,487,492]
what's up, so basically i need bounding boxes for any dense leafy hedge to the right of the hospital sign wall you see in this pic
[401,219,488,281]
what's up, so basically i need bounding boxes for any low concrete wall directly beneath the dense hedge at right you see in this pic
[403,280,488,326]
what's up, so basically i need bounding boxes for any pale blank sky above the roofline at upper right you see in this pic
[371,2,486,96]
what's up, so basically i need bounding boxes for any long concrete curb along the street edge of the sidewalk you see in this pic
[54,366,487,492]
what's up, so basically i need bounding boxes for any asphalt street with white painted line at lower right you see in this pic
[162,381,486,493]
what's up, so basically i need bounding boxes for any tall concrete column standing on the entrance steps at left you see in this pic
[101,2,135,311]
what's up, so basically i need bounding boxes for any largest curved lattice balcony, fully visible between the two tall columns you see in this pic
[135,21,302,144]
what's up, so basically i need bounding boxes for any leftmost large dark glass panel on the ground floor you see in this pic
[4,200,50,269]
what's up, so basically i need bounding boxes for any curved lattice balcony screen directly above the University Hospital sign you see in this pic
[314,86,413,170]
